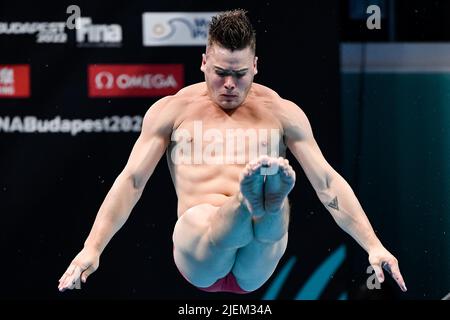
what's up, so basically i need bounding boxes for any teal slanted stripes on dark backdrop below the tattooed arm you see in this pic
[262,245,347,300]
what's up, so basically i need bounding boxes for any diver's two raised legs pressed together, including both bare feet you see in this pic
[173,156,295,291]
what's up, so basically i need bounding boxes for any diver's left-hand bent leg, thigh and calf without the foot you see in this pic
[173,194,253,288]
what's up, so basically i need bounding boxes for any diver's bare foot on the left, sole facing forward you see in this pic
[240,156,270,217]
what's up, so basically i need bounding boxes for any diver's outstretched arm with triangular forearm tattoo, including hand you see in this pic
[282,100,406,291]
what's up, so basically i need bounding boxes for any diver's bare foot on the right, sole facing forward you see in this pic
[264,157,295,213]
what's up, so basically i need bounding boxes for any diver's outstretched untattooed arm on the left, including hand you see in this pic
[58,97,173,291]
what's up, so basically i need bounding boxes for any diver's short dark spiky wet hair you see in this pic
[208,9,256,53]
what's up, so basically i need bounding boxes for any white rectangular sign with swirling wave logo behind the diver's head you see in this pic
[142,12,217,46]
